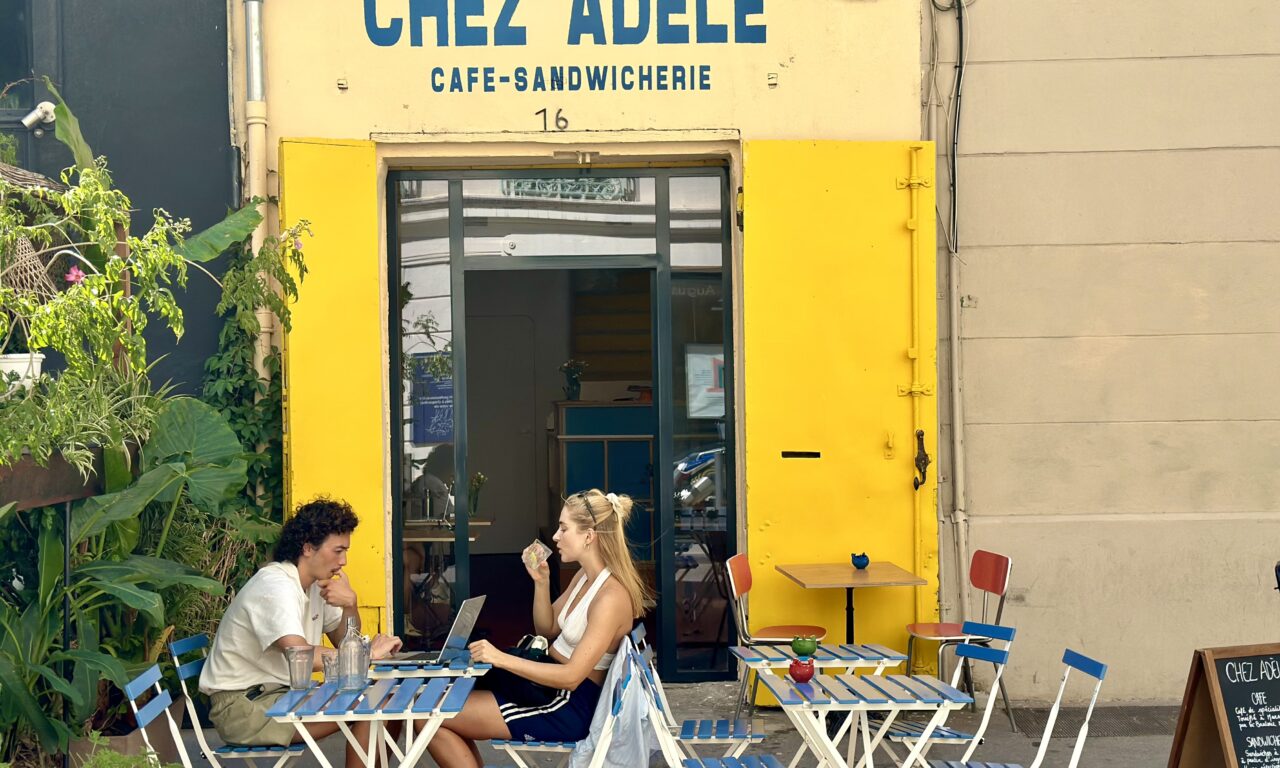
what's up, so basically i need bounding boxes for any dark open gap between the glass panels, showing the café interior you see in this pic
[466,269,657,645]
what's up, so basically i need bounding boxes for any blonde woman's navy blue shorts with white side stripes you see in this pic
[476,669,600,741]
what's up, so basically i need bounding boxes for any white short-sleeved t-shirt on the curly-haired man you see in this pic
[200,562,343,694]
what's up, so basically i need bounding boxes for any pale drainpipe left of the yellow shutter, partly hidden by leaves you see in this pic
[244,0,275,379]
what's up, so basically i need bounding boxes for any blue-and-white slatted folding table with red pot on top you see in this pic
[760,673,973,768]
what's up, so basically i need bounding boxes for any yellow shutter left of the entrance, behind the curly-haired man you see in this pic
[280,140,389,631]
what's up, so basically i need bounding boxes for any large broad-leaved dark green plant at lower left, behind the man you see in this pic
[0,398,247,759]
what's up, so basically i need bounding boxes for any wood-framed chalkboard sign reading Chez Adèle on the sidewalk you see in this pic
[1169,644,1280,768]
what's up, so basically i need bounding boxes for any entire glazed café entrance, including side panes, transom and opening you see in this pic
[388,166,737,681]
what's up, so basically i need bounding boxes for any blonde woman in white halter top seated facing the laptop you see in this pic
[428,489,653,768]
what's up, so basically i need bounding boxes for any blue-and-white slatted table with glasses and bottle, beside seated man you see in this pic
[266,666,488,768]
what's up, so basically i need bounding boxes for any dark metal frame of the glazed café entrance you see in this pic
[387,165,739,682]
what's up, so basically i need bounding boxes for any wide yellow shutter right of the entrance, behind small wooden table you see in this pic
[742,141,938,665]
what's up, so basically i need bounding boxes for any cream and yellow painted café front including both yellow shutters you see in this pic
[257,0,938,648]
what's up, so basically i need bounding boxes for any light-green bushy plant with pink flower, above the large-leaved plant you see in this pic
[0,91,264,476]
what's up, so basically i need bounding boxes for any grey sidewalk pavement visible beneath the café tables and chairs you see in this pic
[183,682,1172,768]
